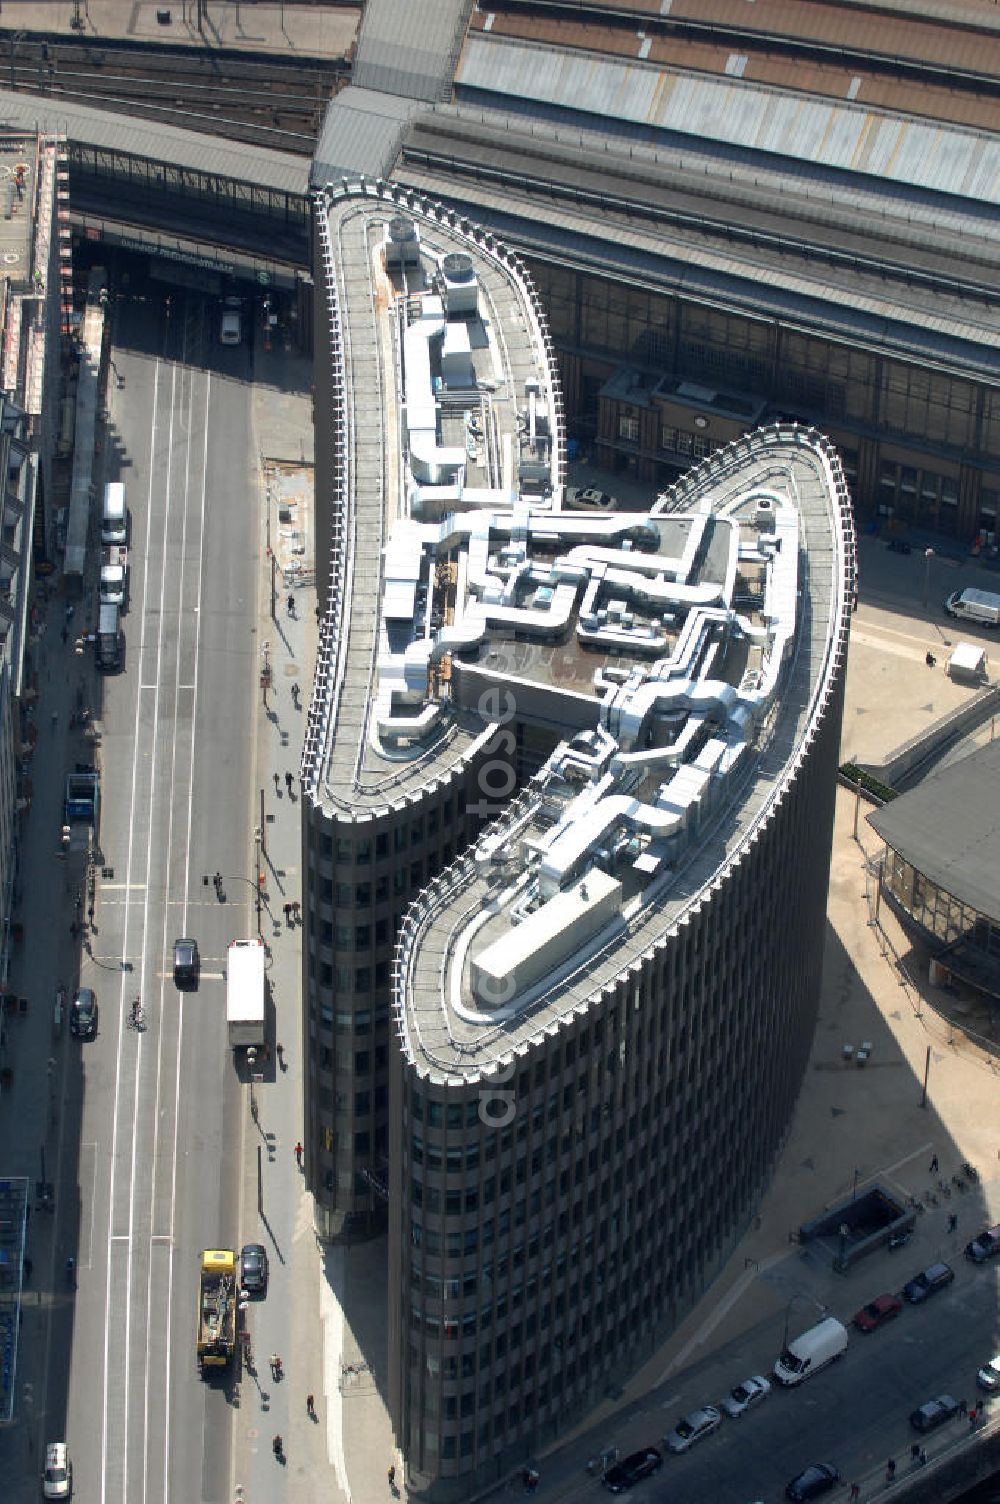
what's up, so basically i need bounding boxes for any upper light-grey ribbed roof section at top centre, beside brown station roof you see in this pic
[352,0,472,101]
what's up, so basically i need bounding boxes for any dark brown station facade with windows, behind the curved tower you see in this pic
[531,259,1000,546]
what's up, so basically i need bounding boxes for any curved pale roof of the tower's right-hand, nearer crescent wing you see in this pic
[394,424,856,1081]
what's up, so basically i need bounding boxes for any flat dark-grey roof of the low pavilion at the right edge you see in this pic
[868,741,1000,920]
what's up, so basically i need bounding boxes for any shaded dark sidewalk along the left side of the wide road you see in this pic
[0,576,103,1501]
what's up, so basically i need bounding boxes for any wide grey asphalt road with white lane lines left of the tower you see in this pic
[59,276,259,1504]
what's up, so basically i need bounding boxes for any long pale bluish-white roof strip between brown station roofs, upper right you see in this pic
[456,32,1000,203]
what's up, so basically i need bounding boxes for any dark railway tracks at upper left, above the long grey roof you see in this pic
[0,30,349,155]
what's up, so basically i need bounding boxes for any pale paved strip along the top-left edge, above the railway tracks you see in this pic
[0,0,361,59]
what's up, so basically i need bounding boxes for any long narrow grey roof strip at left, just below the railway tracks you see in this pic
[0,89,310,194]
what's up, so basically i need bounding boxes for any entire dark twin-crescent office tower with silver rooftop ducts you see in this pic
[304,185,856,1498]
